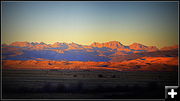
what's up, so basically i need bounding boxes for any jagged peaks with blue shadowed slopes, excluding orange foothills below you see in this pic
[2,41,178,62]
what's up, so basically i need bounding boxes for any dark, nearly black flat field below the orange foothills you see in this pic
[2,69,177,99]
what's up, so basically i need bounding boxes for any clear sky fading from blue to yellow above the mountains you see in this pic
[1,1,178,48]
